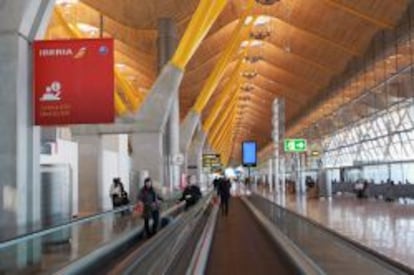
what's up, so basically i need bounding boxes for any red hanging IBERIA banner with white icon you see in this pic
[33,39,115,125]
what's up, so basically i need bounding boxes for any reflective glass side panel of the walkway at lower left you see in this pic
[0,213,143,274]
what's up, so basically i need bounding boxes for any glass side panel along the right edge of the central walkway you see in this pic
[248,194,414,275]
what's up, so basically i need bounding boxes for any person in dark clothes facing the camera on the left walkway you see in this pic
[138,178,163,237]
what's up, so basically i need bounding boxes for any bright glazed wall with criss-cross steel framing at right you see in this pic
[322,99,414,167]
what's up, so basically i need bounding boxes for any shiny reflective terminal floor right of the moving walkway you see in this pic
[260,191,414,268]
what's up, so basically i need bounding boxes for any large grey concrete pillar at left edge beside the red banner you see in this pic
[0,0,53,233]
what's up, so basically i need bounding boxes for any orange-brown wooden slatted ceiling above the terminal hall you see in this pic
[75,0,408,163]
